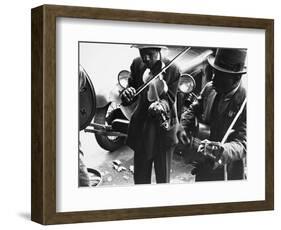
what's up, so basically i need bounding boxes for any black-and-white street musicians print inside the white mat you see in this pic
[77,41,248,187]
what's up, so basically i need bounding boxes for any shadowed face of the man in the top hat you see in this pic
[212,69,241,93]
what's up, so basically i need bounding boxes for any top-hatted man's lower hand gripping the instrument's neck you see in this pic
[197,140,224,161]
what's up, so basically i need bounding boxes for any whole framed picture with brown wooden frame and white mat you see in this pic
[31,5,274,226]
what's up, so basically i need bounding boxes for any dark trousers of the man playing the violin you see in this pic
[134,146,175,184]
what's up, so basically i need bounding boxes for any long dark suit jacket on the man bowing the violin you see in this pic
[127,58,180,157]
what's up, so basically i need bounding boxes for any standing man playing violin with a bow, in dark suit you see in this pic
[121,45,180,184]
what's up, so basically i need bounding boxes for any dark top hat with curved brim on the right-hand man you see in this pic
[208,48,247,74]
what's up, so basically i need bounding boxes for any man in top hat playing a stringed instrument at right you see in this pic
[178,48,247,181]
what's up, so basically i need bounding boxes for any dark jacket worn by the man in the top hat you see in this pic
[181,82,247,180]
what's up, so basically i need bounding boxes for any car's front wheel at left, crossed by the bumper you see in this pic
[94,102,125,152]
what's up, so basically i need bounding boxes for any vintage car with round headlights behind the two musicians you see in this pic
[79,47,213,151]
